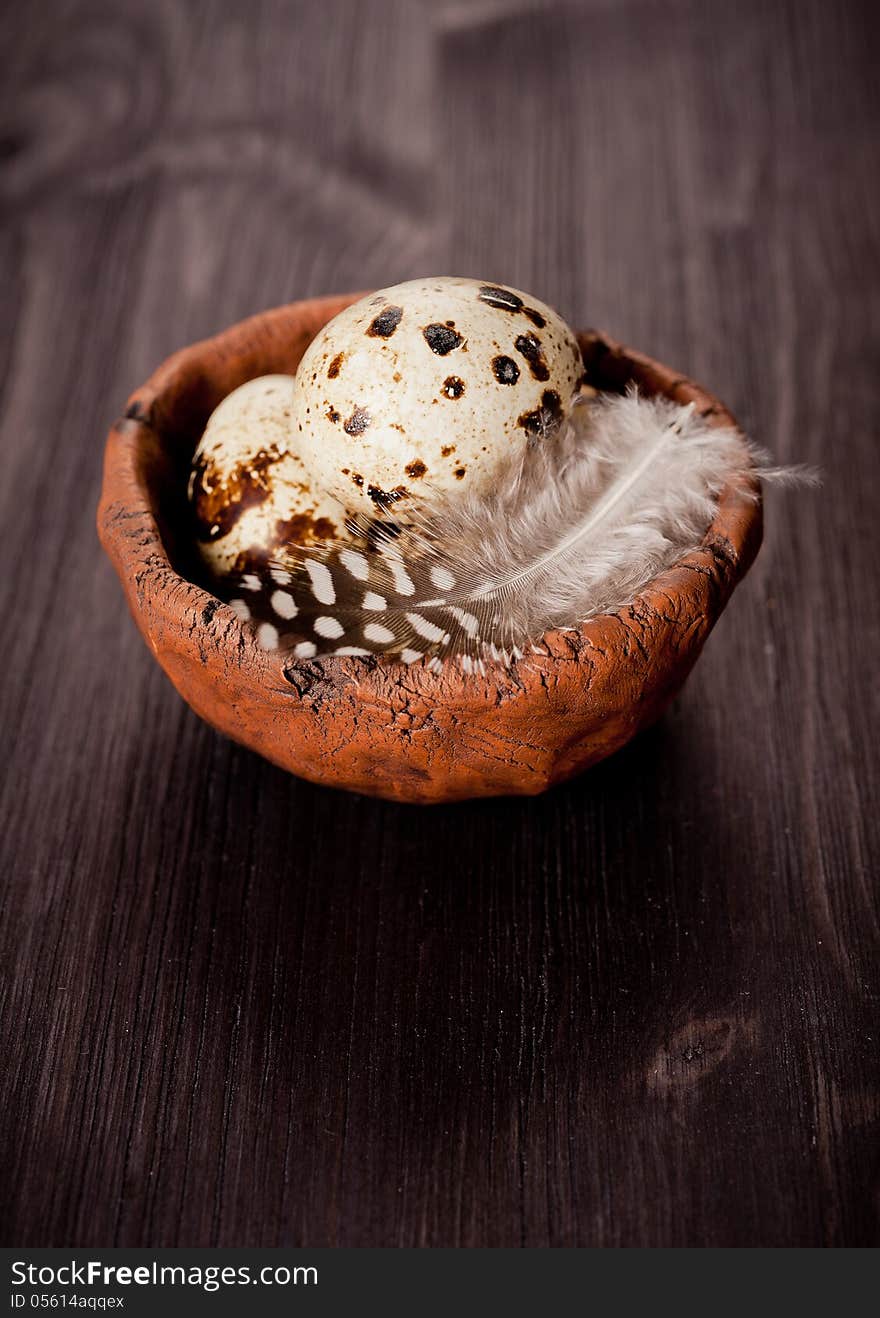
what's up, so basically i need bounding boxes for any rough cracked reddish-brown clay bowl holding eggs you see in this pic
[97,294,761,803]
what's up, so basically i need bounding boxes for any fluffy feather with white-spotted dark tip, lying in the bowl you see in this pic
[226,391,795,671]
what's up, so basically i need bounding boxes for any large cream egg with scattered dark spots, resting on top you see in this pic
[291,277,584,511]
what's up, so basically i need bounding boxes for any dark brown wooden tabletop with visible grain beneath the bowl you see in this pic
[0,0,880,1246]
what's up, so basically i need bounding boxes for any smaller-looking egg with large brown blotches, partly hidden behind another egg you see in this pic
[190,376,341,573]
